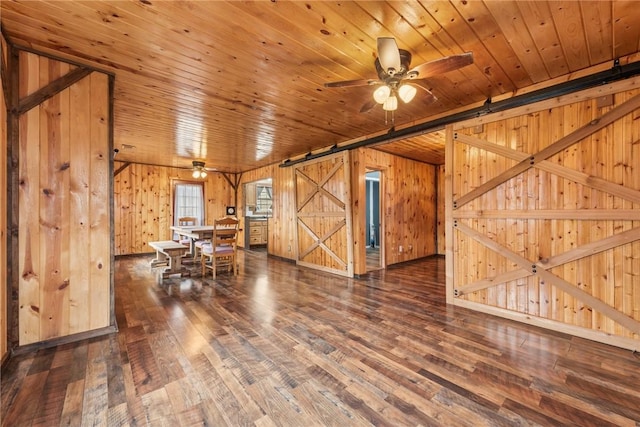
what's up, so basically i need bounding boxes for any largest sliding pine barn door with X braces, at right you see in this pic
[446,78,640,349]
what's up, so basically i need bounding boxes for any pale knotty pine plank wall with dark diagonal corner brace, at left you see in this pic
[10,51,115,346]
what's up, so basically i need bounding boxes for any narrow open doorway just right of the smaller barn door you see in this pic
[365,170,384,272]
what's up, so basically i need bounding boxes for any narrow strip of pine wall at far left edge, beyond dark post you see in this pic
[0,35,9,361]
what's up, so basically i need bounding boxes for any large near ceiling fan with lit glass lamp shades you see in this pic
[324,37,473,117]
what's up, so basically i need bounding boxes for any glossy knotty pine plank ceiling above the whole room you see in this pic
[0,0,640,172]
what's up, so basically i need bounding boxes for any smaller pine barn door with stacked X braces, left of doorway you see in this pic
[295,152,353,277]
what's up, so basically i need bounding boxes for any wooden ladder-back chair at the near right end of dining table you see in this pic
[200,217,239,279]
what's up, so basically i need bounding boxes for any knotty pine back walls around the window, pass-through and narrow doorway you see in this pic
[114,148,437,274]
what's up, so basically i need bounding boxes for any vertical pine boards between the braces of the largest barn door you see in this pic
[445,84,640,352]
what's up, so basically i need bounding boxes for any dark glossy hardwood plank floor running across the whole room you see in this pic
[2,251,640,427]
